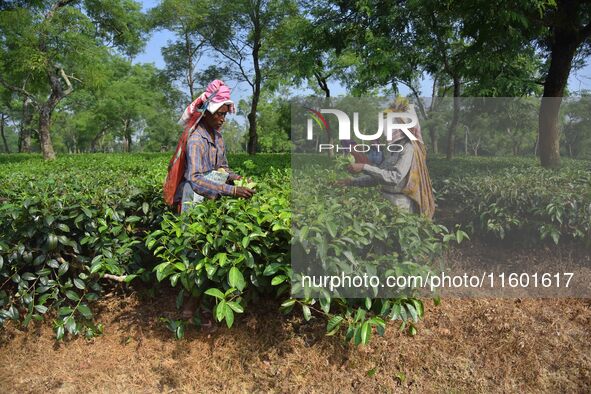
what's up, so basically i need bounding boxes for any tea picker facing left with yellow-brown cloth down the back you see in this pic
[337,99,435,219]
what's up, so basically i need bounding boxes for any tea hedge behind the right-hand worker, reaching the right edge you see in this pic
[433,155,591,244]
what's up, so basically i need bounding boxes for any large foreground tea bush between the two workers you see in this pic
[146,159,465,344]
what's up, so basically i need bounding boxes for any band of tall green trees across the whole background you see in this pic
[0,0,591,167]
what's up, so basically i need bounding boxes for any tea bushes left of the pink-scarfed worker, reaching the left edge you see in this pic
[0,155,165,339]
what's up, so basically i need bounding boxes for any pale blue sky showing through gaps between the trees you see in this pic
[134,0,591,113]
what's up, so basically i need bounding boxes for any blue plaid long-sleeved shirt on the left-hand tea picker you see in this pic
[179,125,240,199]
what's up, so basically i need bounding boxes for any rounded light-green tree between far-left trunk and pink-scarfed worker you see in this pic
[55,56,180,152]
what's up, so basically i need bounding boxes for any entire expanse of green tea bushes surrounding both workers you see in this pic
[0,154,591,343]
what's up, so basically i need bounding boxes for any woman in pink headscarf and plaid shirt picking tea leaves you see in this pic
[175,80,255,211]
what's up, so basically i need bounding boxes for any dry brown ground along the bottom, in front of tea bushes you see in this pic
[0,242,591,393]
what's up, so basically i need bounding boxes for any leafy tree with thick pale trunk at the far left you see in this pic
[0,0,144,159]
